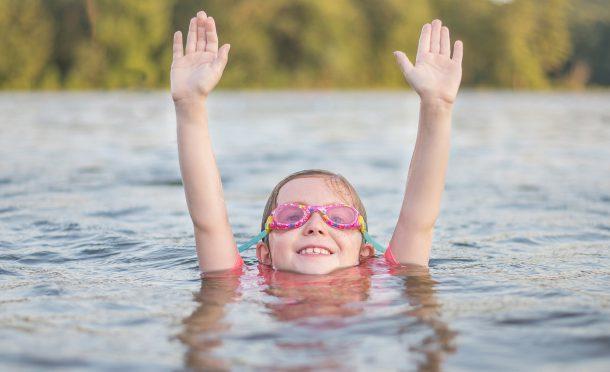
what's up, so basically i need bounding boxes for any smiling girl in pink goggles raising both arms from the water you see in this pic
[171,11,463,274]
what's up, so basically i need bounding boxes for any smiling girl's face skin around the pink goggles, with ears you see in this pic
[257,177,374,274]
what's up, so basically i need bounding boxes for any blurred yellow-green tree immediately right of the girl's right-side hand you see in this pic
[434,0,571,88]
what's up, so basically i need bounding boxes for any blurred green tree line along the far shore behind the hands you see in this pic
[0,0,610,89]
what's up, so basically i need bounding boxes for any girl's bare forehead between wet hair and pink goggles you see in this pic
[277,177,352,205]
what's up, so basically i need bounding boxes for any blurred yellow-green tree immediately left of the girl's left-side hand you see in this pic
[68,0,173,88]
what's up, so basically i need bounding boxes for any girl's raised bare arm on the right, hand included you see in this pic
[390,19,463,266]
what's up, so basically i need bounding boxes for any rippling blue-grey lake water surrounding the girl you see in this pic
[0,91,610,371]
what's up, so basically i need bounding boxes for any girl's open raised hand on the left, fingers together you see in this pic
[170,11,231,103]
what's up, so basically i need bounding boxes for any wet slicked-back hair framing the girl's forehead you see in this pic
[261,169,367,244]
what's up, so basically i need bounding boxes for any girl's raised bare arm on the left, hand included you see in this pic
[171,11,239,272]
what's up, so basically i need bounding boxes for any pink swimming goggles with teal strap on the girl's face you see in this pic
[238,203,385,253]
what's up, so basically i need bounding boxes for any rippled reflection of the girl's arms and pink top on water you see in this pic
[178,260,456,371]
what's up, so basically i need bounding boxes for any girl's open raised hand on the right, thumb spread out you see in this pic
[394,19,463,105]
